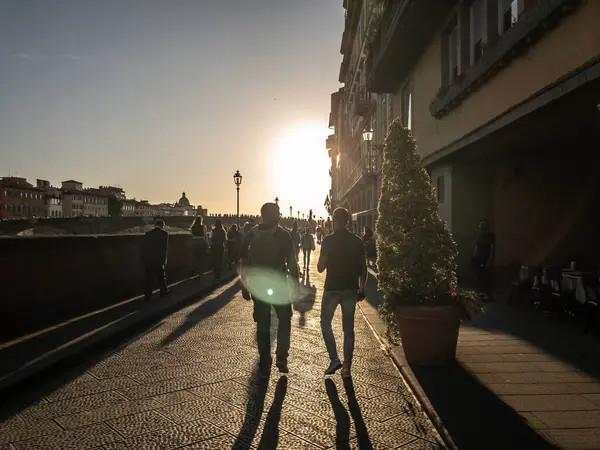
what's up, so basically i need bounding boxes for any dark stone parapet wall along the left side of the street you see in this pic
[0,234,199,342]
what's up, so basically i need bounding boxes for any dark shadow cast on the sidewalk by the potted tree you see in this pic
[411,362,556,450]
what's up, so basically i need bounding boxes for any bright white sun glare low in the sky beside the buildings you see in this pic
[271,124,331,217]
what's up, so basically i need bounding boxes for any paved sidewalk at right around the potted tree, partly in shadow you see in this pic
[364,272,600,450]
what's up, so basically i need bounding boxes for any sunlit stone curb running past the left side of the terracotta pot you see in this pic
[358,269,458,450]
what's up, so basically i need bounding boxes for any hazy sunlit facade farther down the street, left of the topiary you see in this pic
[326,0,392,233]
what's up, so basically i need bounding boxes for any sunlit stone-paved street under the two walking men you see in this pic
[0,251,442,450]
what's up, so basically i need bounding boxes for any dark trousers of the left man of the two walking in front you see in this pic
[253,299,292,364]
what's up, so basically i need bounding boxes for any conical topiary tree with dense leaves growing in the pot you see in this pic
[377,119,459,311]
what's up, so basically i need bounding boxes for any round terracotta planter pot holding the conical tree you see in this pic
[394,306,460,366]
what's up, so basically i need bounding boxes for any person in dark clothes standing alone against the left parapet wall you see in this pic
[140,220,169,300]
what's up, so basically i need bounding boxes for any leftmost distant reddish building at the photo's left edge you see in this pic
[0,177,45,219]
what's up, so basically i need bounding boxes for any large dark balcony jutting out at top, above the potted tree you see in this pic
[367,0,456,93]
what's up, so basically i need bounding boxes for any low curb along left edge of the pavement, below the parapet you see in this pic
[0,272,237,392]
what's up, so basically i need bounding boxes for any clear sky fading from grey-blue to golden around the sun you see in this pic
[0,0,344,215]
